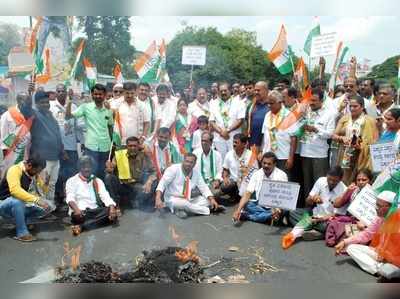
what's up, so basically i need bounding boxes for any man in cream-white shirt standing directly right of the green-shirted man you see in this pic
[114,82,150,145]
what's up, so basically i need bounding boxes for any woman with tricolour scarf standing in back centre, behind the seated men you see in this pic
[175,99,197,154]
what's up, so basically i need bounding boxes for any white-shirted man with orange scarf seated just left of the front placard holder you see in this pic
[213,133,258,205]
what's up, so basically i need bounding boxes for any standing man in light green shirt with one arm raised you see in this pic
[66,84,113,179]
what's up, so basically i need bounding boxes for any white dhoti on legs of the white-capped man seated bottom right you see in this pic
[346,244,383,275]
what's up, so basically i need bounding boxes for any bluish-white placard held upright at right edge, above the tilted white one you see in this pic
[369,142,396,172]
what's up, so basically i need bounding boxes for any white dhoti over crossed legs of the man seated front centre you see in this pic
[165,196,210,215]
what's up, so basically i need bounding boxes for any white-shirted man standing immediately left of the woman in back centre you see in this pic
[155,84,177,131]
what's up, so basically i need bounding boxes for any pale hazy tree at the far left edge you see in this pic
[0,24,22,65]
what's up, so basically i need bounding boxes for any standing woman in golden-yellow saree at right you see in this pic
[332,95,378,185]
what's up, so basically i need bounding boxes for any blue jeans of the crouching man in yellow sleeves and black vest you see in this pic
[0,197,46,237]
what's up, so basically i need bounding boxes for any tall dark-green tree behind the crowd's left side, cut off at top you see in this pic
[70,16,137,78]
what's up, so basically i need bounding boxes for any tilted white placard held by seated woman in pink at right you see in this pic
[347,186,377,225]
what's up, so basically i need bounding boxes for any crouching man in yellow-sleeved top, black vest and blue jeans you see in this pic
[0,156,51,242]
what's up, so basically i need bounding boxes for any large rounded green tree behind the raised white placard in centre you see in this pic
[167,26,287,90]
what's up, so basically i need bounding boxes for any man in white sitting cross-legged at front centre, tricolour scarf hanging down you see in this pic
[156,154,219,218]
